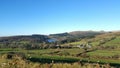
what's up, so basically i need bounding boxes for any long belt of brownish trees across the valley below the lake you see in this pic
[0,42,70,49]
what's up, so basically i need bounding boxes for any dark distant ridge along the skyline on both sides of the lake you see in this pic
[0,31,103,43]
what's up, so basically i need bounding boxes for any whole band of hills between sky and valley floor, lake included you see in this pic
[0,31,120,48]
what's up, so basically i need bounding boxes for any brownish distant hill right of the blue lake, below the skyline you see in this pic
[49,31,106,41]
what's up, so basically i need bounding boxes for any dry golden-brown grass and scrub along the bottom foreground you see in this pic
[0,56,111,68]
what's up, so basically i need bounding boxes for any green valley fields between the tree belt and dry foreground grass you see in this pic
[0,48,120,66]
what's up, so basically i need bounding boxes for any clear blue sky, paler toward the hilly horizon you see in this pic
[0,0,120,36]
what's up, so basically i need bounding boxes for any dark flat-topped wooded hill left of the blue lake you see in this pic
[0,35,49,43]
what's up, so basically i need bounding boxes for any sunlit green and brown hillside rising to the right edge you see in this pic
[65,31,120,49]
